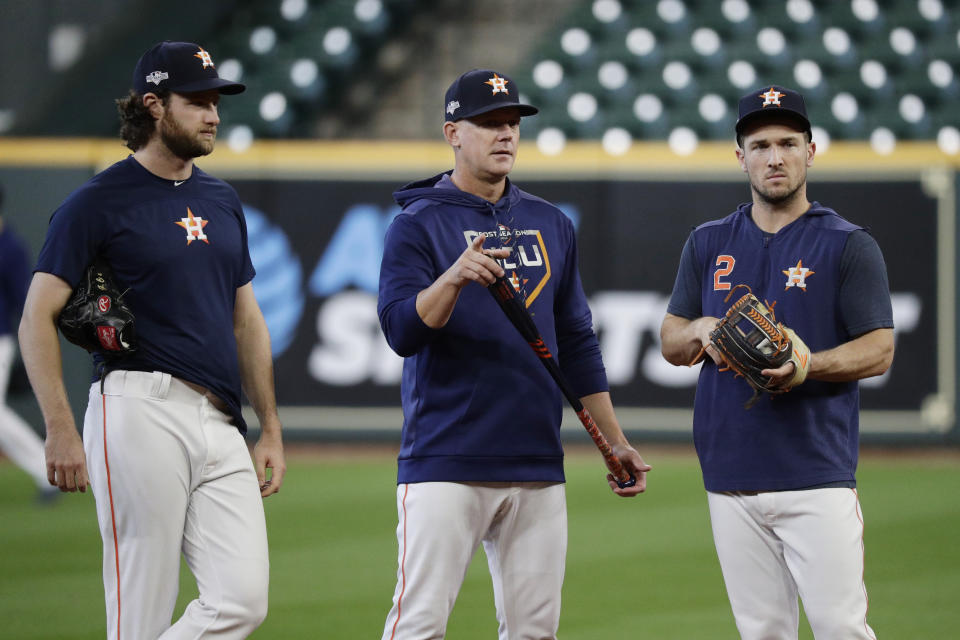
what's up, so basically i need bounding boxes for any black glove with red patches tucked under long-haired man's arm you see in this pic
[57,258,137,358]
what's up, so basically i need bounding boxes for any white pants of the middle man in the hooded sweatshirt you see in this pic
[383,482,567,640]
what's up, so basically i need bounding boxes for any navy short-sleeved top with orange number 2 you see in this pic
[667,202,893,491]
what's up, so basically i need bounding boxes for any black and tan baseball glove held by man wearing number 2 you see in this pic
[694,285,810,409]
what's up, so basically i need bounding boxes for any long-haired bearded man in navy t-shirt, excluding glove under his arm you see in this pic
[20,42,285,639]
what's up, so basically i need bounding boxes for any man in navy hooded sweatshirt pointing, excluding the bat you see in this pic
[378,70,650,640]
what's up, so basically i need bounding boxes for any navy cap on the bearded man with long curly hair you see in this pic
[133,40,247,95]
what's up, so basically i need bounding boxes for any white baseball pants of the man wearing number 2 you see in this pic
[707,488,876,640]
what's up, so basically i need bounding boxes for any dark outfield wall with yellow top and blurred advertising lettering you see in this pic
[0,139,960,440]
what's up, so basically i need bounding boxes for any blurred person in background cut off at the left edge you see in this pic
[0,186,58,503]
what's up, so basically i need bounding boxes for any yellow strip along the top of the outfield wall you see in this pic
[0,138,960,179]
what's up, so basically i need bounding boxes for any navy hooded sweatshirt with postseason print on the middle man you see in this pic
[377,172,608,483]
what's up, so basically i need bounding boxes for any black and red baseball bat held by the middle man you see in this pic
[487,276,637,489]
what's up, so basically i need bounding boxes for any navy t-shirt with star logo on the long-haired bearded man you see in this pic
[36,156,255,432]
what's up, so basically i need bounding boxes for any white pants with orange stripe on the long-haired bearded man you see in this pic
[83,371,269,640]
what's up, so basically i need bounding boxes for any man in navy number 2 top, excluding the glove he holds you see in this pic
[660,86,893,640]
